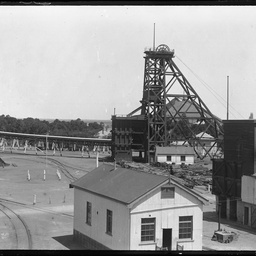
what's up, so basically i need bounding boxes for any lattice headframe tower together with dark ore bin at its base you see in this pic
[112,44,223,162]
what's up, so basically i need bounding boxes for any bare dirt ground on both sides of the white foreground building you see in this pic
[0,151,256,251]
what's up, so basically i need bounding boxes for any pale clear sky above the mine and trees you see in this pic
[0,5,256,120]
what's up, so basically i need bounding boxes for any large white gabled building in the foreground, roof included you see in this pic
[71,164,206,250]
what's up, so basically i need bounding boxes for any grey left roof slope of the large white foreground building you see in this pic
[71,164,168,204]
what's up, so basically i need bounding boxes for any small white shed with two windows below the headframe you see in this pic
[155,145,195,164]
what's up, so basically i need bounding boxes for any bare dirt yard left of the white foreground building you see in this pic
[0,151,104,250]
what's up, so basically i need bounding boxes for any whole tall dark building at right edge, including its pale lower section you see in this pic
[212,120,256,228]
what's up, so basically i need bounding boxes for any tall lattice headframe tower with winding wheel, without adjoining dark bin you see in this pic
[128,44,223,162]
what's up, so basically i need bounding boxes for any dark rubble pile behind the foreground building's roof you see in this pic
[117,161,212,188]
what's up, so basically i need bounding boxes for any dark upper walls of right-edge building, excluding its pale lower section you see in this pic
[212,120,255,220]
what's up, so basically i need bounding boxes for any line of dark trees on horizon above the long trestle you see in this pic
[0,115,104,138]
